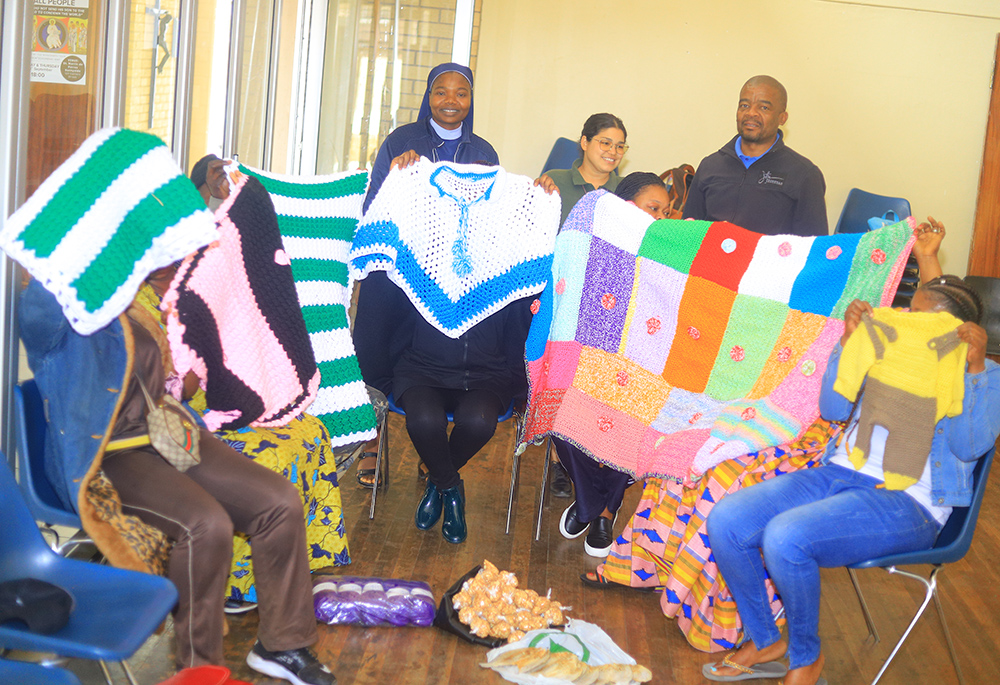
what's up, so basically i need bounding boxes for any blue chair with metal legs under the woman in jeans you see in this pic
[848,447,996,685]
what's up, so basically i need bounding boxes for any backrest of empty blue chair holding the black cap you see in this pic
[0,452,59,581]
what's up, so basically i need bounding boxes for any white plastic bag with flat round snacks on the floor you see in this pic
[479,620,653,685]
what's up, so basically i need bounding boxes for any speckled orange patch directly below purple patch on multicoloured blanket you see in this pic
[573,347,670,425]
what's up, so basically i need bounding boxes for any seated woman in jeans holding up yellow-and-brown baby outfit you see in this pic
[703,276,1000,685]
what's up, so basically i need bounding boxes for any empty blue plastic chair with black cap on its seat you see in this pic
[0,454,177,683]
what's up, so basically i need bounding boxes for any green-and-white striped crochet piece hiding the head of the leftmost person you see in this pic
[0,128,218,335]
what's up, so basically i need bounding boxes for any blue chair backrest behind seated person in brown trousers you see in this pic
[14,380,80,528]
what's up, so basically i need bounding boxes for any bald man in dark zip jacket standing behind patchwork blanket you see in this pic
[684,76,828,236]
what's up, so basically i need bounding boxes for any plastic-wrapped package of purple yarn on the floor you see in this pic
[313,576,437,626]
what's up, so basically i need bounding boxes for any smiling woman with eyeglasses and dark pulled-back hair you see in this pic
[535,112,628,226]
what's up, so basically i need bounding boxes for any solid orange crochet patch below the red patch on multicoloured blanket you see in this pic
[663,276,736,392]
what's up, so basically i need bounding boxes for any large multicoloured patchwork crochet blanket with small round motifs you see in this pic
[524,190,913,480]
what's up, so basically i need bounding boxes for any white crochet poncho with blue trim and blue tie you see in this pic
[349,157,561,338]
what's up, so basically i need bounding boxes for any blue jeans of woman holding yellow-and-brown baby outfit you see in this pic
[707,465,940,668]
